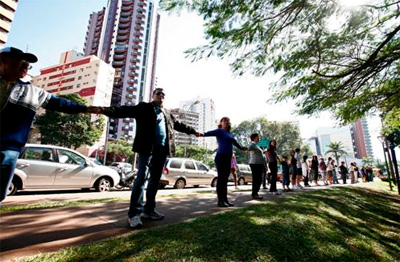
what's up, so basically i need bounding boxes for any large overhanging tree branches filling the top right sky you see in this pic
[160,0,400,131]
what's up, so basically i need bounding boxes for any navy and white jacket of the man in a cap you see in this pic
[0,78,87,151]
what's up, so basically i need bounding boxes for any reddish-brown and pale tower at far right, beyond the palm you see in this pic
[350,118,374,159]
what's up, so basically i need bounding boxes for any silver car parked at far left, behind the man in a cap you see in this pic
[9,144,120,195]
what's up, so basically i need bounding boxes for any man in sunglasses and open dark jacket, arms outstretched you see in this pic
[88,88,200,228]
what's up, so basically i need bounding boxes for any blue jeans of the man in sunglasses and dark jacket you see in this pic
[128,147,167,218]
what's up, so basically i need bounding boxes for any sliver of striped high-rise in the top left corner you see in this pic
[0,0,18,48]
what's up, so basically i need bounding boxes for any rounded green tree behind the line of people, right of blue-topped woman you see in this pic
[232,117,301,163]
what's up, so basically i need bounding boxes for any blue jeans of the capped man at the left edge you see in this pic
[0,150,19,203]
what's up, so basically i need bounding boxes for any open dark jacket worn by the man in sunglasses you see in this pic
[104,102,196,156]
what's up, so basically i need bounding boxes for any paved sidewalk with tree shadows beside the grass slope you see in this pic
[0,186,340,261]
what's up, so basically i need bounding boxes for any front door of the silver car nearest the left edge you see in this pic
[54,149,93,188]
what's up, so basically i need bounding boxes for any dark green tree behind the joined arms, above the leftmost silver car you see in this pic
[35,94,104,149]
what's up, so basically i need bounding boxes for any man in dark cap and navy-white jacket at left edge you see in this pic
[0,47,87,203]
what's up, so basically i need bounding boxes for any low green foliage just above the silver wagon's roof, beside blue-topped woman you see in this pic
[175,145,215,167]
